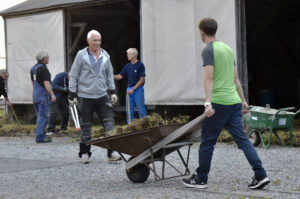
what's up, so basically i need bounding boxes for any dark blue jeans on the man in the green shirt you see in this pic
[196,103,266,182]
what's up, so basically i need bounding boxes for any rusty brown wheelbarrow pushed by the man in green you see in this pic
[87,115,205,183]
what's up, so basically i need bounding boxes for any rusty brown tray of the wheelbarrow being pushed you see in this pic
[87,124,188,156]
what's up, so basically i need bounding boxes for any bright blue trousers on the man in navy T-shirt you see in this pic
[126,86,147,123]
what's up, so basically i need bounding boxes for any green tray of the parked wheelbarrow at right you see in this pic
[243,106,295,129]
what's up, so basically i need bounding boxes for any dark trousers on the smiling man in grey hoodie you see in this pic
[78,95,115,143]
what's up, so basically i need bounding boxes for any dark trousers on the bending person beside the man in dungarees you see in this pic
[48,95,69,132]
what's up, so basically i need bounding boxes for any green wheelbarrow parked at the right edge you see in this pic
[243,105,300,149]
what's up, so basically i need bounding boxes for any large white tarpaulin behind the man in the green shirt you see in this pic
[141,0,236,105]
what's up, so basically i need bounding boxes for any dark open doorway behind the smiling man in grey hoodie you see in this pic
[66,0,140,106]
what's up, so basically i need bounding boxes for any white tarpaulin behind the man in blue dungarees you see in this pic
[6,10,65,104]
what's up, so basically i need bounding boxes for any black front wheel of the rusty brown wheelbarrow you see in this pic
[126,157,150,183]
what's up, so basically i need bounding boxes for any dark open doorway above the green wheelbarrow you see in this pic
[245,0,300,108]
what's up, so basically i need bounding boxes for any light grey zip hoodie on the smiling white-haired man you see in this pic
[69,47,116,99]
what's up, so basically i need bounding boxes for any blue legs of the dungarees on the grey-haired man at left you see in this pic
[34,97,50,142]
